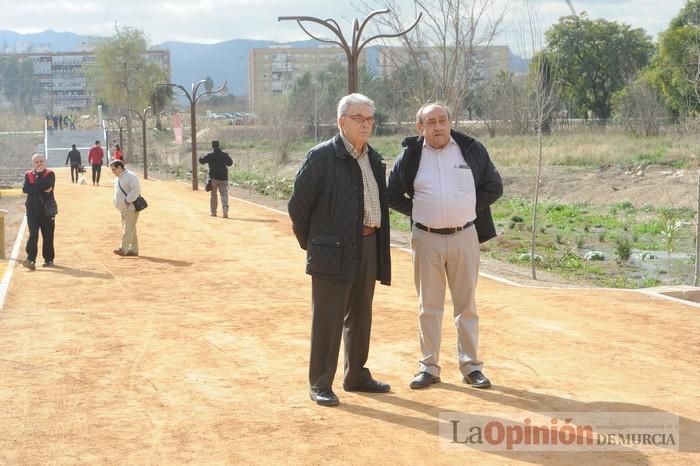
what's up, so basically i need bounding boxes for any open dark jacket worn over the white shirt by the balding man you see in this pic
[388,131,503,243]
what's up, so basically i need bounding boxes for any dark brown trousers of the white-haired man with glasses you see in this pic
[309,234,377,390]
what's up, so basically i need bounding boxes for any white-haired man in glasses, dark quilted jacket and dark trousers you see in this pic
[288,94,391,406]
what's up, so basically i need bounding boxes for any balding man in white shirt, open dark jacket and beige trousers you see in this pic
[388,102,503,389]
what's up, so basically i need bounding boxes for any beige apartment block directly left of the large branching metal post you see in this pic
[248,44,367,112]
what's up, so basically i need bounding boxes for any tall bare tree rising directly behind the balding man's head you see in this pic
[361,0,506,118]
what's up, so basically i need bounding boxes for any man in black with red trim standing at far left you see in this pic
[22,154,56,270]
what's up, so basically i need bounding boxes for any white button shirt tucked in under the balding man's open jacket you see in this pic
[412,138,476,228]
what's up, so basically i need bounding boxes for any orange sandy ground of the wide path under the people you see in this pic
[0,169,700,465]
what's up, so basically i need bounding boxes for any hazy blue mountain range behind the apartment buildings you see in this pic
[0,29,527,96]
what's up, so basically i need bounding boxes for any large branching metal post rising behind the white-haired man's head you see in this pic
[277,9,423,94]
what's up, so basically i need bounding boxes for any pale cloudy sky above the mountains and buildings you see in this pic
[0,0,685,49]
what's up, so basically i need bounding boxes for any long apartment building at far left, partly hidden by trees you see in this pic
[0,50,170,113]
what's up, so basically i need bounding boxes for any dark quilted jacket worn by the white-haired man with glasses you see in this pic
[288,135,391,285]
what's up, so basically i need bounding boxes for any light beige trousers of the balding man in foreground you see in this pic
[411,226,483,376]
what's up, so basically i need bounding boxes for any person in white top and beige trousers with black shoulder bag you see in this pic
[109,160,143,256]
